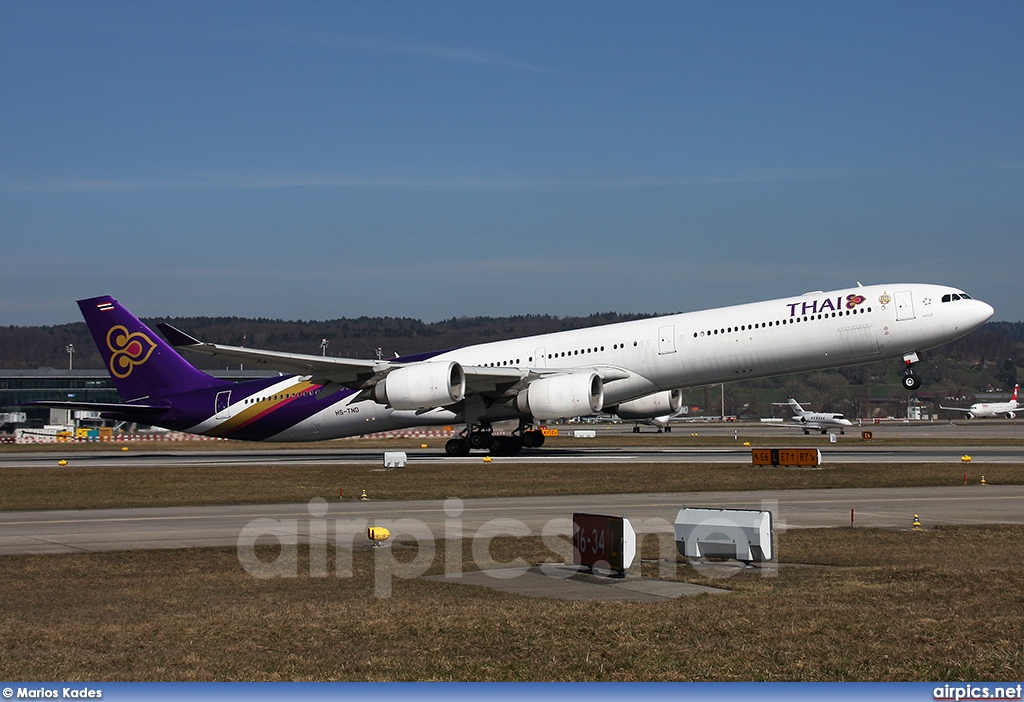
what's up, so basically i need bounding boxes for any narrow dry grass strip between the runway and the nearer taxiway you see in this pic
[0,458,1024,511]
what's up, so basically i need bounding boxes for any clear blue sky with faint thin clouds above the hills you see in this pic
[0,0,1024,325]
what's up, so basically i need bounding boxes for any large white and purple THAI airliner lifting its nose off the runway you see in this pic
[28,283,992,455]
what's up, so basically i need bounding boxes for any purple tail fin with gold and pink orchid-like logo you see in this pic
[78,296,223,401]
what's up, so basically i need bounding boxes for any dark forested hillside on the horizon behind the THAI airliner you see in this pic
[0,312,1024,418]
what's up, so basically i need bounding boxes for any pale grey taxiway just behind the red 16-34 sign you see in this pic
[0,485,1024,555]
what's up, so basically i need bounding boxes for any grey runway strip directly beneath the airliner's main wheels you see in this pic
[0,420,1024,470]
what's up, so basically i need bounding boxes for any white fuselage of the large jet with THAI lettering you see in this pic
[273,283,992,440]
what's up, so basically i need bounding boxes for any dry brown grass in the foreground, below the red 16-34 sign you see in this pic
[0,526,1024,682]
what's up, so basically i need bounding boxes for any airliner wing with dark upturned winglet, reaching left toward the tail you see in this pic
[157,323,385,387]
